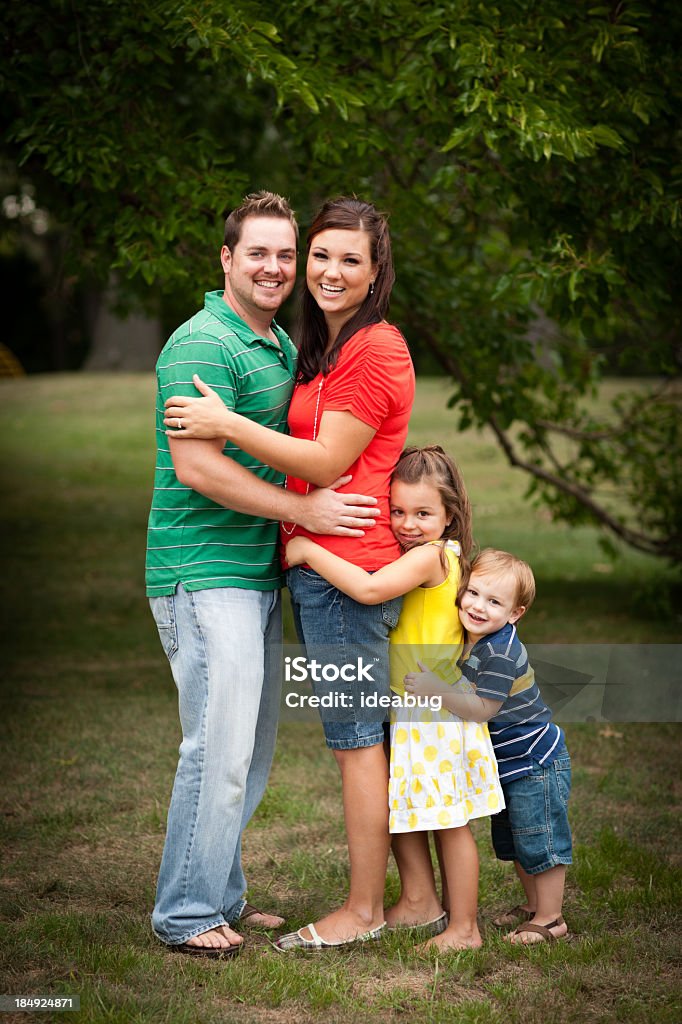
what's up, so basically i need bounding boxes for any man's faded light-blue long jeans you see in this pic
[150,584,282,945]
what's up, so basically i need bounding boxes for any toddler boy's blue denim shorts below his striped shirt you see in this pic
[491,748,572,874]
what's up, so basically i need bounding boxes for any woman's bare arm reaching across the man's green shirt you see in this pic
[164,374,376,487]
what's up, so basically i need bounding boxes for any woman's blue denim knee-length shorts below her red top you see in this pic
[287,565,402,751]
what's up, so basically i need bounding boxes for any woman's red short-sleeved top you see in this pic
[281,322,415,571]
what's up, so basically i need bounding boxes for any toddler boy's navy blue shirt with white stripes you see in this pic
[460,623,564,784]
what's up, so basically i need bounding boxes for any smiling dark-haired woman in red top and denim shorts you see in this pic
[166,198,415,949]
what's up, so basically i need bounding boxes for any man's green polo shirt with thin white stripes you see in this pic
[146,292,296,597]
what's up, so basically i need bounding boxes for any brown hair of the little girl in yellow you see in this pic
[391,444,473,577]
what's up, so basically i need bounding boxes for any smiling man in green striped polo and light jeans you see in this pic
[146,193,373,956]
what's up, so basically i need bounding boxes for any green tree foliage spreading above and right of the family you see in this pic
[0,0,682,561]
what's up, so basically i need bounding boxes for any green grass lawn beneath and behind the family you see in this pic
[0,375,682,1024]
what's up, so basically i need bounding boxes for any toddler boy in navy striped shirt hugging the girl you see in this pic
[404,548,572,944]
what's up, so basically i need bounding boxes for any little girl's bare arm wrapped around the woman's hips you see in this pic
[286,537,445,604]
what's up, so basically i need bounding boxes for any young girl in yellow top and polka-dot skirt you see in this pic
[287,444,504,949]
